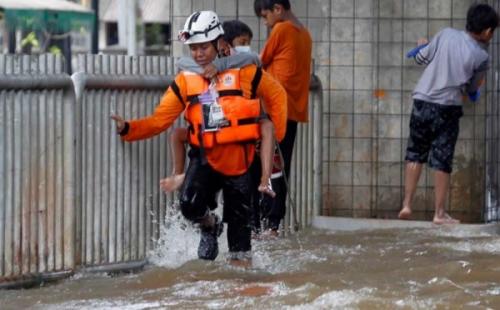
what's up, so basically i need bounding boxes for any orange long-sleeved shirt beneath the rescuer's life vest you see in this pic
[122,65,287,175]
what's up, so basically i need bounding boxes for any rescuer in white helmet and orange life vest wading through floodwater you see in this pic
[111,11,287,266]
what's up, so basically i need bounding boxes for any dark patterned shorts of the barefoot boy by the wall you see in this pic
[405,99,463,173]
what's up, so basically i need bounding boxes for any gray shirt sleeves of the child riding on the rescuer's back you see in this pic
[177,53,260,74]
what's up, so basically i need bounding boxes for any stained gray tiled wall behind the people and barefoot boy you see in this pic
[172,0,485,221]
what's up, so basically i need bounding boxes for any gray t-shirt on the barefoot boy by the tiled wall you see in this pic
[413,28,489,105]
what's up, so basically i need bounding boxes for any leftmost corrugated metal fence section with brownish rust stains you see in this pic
[0,55,78,283]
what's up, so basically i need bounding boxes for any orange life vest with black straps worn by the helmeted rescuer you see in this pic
[182,69,261,149]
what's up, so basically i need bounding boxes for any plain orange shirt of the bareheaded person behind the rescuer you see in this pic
[261,21,312,122]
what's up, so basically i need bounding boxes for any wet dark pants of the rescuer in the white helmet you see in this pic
[180,148,252,252]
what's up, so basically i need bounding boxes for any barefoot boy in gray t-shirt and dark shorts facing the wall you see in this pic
[399,4,498,224]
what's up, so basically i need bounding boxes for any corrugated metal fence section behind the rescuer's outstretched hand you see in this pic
[73,55,178,268]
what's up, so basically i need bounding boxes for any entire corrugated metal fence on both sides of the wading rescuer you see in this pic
[0,55,322,287]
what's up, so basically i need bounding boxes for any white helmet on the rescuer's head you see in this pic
[179,11,224,44]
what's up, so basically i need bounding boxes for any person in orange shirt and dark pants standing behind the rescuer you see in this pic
[254,0,312,235]
